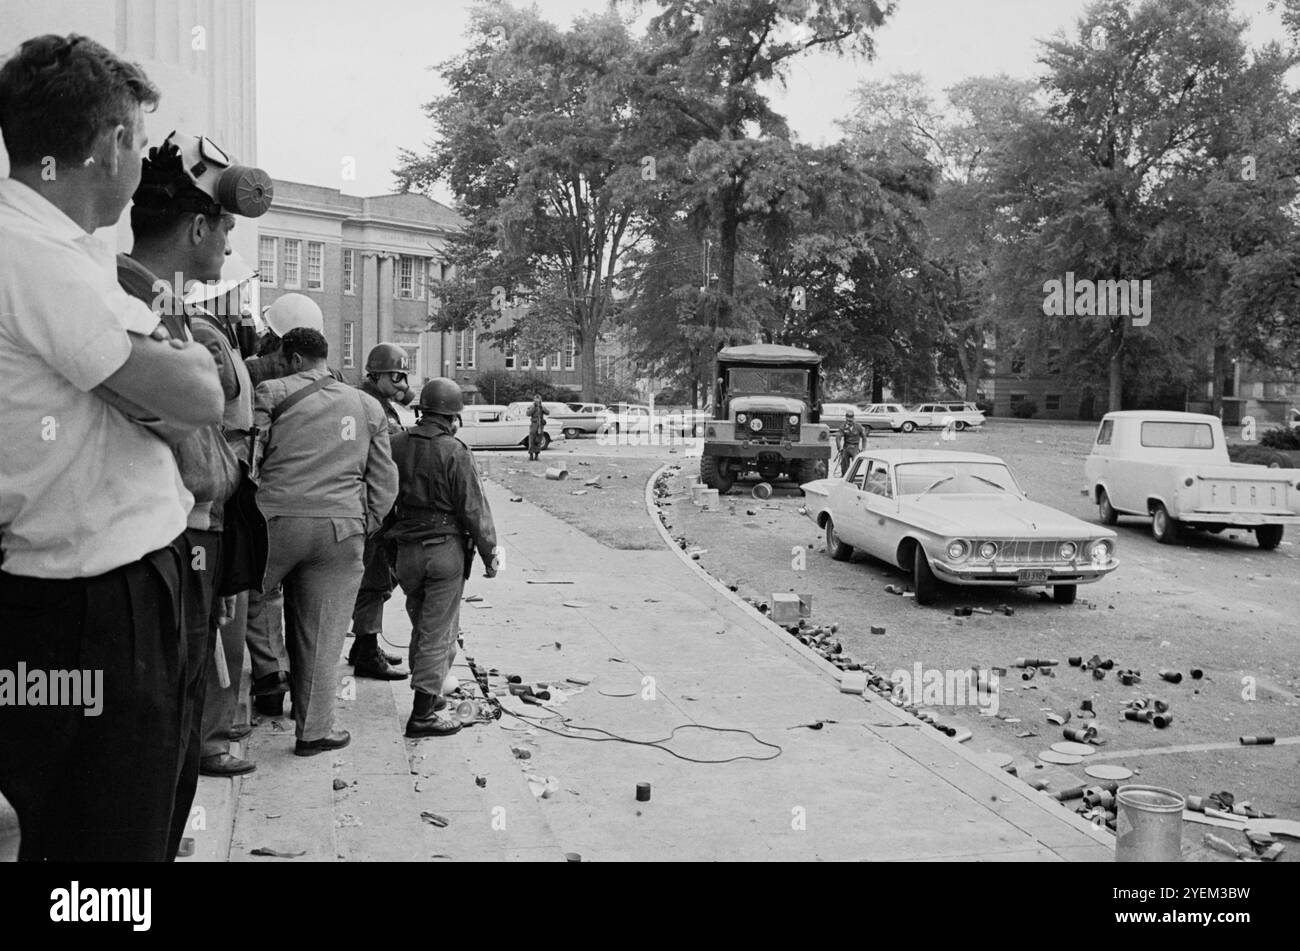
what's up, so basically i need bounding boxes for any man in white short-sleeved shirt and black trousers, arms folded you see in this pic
[0,35,224,861]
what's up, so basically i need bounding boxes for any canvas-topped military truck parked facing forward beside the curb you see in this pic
[699,343,832,494]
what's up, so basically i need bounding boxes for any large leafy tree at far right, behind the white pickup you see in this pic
[982,0,1296,409]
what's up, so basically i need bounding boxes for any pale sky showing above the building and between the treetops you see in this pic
[256,0,1282,203]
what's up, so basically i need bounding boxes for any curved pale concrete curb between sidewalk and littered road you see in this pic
[645,463,1115,848]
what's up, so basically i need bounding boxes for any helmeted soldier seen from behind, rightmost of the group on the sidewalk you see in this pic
[386,377,497,737]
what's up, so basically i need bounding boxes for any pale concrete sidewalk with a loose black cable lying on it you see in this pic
[192,472,1113,861]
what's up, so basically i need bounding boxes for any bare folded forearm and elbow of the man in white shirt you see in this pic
[101,334,225,430]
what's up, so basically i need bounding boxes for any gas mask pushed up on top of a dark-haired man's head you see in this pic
[137,133,274,218]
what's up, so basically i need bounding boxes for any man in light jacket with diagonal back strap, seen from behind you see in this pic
[254,327,398,756]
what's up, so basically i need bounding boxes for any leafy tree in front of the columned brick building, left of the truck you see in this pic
[397,3,658,399]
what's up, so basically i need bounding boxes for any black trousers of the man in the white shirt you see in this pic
[0,537,186,861]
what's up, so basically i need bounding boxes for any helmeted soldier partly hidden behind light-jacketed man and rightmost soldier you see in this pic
[347,343,410,681]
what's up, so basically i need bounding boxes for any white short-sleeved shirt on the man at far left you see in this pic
[0,179,194,578]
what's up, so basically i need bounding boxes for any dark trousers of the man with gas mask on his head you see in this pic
[168,529,221,859]
